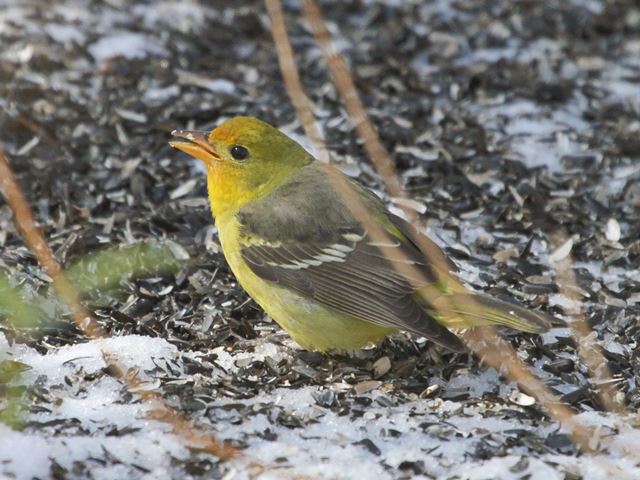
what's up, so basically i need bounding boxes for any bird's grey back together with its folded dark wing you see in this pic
[237,162,463,350]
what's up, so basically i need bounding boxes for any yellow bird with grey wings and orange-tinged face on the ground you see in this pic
[169,117,552,352]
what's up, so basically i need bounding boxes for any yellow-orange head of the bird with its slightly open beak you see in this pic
[169,117,313,217]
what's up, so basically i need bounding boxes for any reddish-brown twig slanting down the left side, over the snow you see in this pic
[0,145,238,460]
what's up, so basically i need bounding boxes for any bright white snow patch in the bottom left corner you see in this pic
[0,335,188,480]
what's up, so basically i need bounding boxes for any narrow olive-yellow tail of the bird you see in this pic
[434,293,557,333]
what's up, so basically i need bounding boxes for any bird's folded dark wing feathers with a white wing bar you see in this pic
[241,225,463,350]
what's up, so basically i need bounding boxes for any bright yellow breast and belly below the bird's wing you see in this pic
[216,216,396,352]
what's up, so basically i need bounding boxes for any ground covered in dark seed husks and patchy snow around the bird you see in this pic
[0,0,640,478]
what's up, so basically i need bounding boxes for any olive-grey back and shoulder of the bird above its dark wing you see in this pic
[236,162,456,271]
